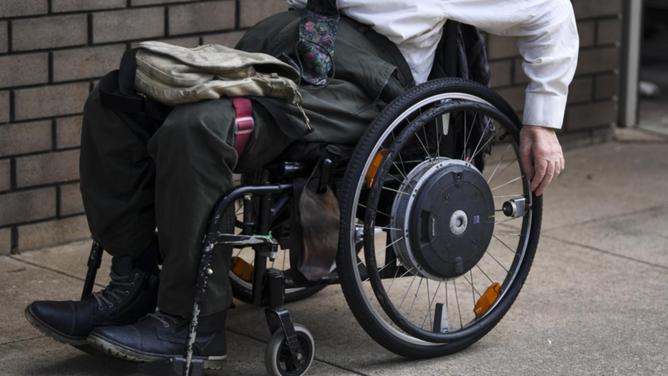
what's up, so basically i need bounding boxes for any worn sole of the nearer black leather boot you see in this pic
[88,334,227,370]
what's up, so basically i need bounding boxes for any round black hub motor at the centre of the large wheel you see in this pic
[390,158,494,280]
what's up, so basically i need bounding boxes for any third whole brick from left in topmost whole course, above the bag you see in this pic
[169,0,236,35]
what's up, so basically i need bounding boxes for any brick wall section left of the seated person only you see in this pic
[0,0,287,254]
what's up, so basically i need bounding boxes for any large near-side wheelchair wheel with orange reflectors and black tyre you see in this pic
[337,79,542,358]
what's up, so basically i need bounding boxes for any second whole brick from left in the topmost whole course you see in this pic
[93,8,165,43]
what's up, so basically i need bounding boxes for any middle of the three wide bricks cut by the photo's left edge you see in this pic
[0,120,52,157]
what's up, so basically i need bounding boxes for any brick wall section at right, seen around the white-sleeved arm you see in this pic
[488,0,623,147]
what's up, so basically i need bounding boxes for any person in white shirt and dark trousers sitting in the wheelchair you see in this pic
[26,0,578,370]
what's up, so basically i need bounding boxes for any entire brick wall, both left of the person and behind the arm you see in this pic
[0,0,622,254]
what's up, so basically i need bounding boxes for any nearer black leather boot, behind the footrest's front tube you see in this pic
[88,311,227,368]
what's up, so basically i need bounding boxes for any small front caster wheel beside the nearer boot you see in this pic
[264,324,315,376]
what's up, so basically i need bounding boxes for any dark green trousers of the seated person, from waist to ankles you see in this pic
[81,12,413,317]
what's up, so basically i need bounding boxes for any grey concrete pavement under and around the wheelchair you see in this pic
[0,137,668,375]
